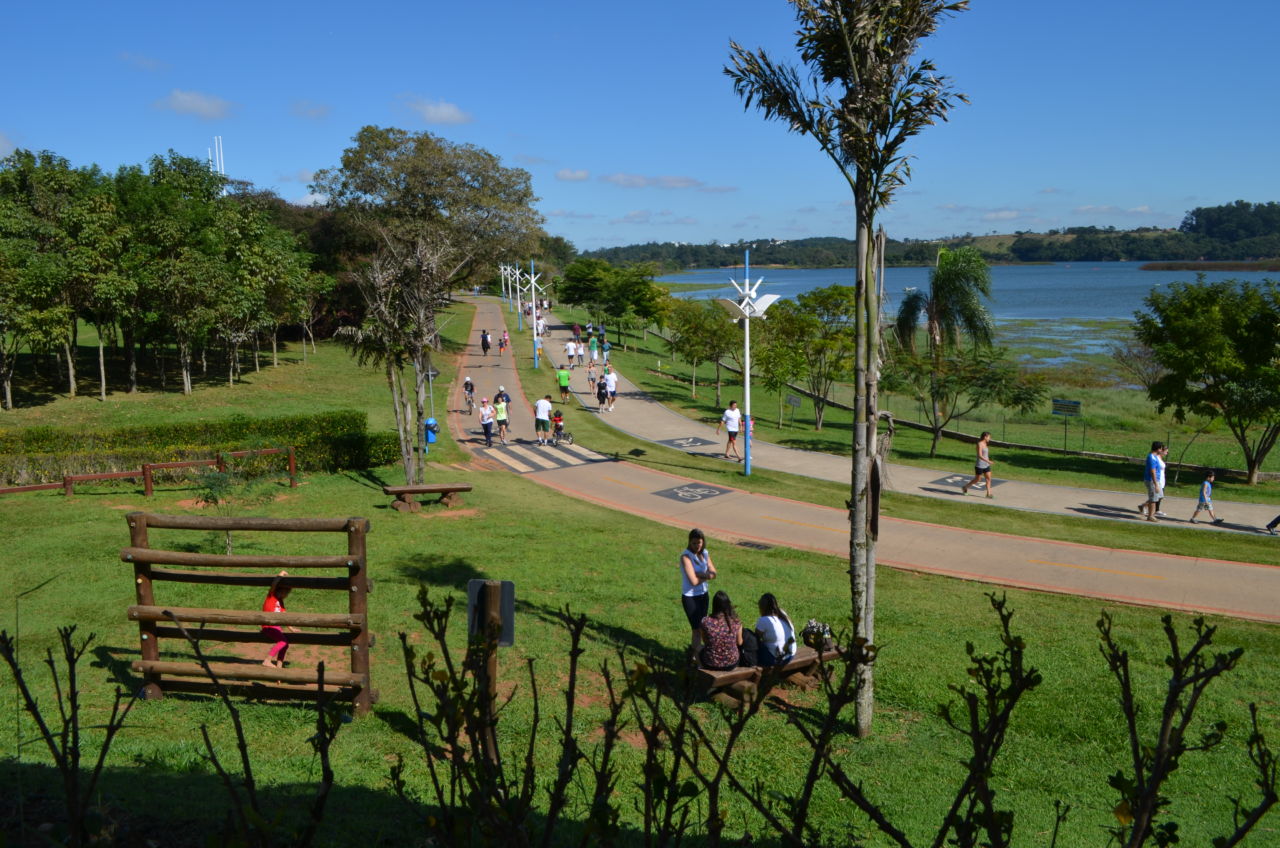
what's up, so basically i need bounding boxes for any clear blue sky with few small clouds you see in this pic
[0,0,1280,250]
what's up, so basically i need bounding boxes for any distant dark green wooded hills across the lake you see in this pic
[584,200,1280,272]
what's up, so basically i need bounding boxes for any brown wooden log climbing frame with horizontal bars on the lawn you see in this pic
[120,512,378,715]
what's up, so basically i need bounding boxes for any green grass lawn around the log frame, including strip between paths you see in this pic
[0,298,1280,847]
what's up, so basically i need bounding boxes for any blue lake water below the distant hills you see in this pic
[658,263,1280,322]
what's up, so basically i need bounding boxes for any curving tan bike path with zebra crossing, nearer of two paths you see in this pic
[449,298,1280,623]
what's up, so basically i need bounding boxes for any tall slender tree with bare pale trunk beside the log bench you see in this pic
[724,0,969,735]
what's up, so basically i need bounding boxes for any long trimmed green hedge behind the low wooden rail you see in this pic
[0,410,399,485]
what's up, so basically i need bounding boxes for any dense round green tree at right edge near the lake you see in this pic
[1134,277,1280,485]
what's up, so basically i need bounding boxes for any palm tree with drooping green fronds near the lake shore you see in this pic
[896,247,995,456]
